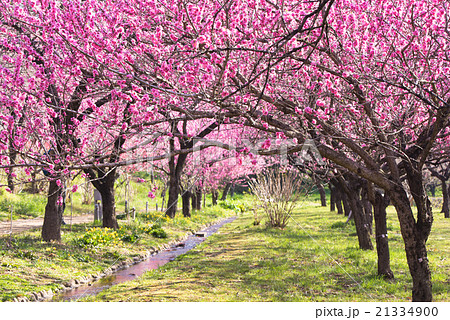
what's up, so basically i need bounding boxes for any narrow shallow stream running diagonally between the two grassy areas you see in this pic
[51,217,236,301]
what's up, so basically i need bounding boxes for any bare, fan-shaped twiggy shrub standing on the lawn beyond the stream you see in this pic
[249,169,302,229]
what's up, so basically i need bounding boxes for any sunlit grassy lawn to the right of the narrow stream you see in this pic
[81,202,450,301]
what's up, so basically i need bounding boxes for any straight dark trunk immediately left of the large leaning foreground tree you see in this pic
[369,191,394,279]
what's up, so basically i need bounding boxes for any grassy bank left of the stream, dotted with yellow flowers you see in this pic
[0,206,235,301]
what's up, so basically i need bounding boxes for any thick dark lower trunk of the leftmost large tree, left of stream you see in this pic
[42,179,63,242]
